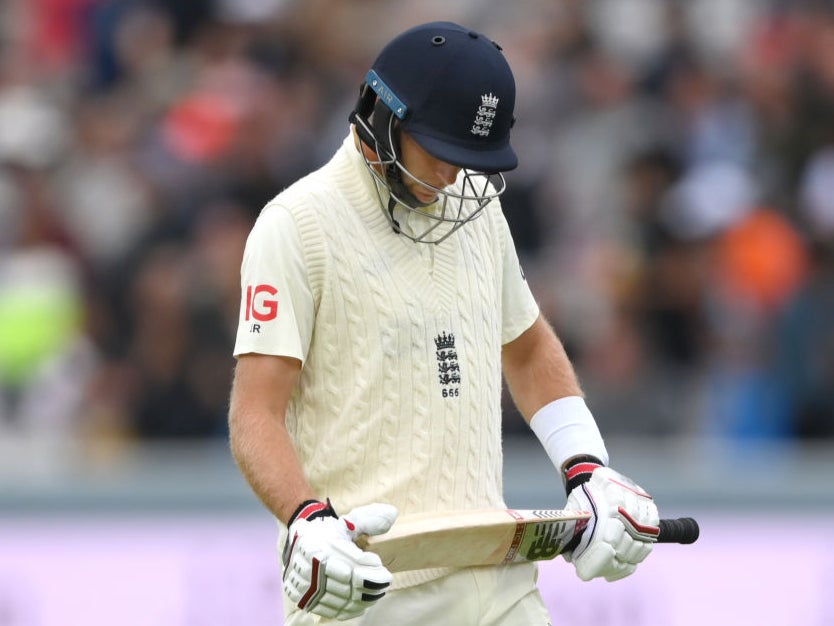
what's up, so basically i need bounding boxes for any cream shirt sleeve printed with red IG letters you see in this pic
[234,205,315,363]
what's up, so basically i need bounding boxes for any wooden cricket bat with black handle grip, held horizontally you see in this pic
[356,509,699,572]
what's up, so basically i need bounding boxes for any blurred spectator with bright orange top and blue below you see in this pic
[706,208,807,440]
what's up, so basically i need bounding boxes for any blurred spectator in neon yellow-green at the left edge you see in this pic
[0,167,97,437]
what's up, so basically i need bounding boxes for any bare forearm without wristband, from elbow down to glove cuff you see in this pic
[229,409,316,523]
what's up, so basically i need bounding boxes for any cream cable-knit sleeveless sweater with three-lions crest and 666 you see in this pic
[274,139,528,586]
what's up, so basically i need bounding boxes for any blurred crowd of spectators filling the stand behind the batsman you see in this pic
[0,0,834,441]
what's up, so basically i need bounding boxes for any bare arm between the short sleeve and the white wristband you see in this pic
[502,316,582,422]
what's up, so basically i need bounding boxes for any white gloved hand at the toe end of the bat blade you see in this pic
[283,501,397,620]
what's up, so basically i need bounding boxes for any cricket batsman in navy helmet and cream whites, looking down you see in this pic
[229,22,658,626]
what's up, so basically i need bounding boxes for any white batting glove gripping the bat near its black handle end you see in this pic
[563,461,660,581]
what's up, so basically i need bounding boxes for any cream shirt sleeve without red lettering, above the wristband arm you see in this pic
[500,215,539,344]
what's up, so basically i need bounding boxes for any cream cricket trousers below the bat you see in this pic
[284,563,551,626]
